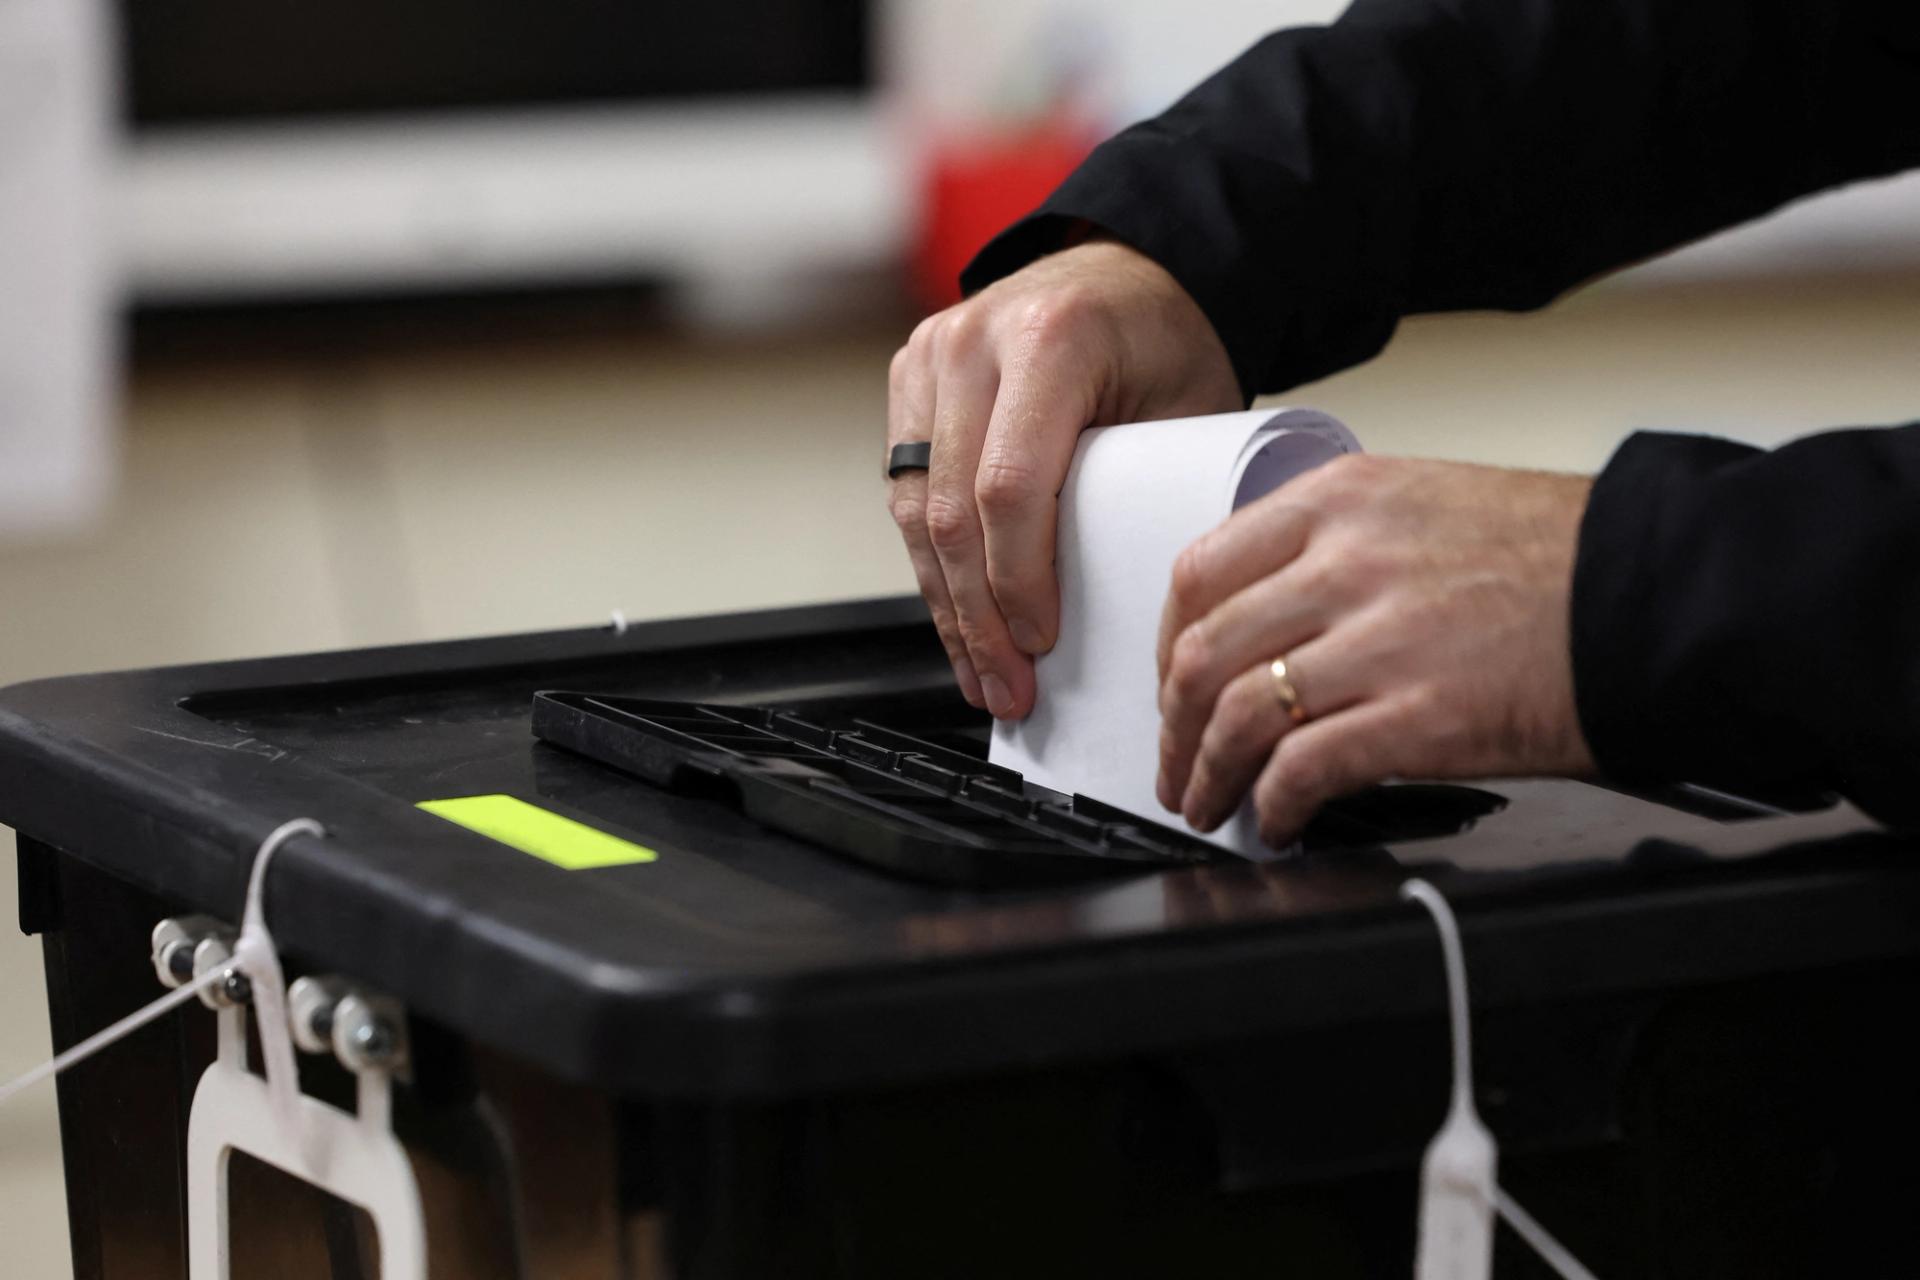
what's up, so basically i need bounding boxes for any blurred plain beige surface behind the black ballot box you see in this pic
[0,278,1920,1280]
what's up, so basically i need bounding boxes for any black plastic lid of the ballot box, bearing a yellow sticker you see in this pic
[0,599,1920,1098]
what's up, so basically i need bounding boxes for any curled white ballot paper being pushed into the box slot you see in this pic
[991,409,1359,858]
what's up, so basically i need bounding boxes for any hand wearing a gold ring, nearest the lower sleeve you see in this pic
[1158,455,1594,846]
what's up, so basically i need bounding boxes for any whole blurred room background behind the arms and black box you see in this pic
[0,0,1920,1276]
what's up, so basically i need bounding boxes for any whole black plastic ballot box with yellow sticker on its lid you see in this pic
[0,601,1920,1280]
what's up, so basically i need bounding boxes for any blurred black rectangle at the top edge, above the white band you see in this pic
[119,0,874,125]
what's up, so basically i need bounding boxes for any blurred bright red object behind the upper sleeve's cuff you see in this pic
[912,121,1098,311]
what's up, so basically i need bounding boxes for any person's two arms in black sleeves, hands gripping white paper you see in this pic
[889,0,1920,850]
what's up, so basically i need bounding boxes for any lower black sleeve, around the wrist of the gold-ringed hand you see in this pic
[1572,424,1920,825]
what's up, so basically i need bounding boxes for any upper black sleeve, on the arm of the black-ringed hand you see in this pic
[962,0,1920,395]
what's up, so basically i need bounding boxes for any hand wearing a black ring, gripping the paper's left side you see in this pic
[887,240,1242,718]
